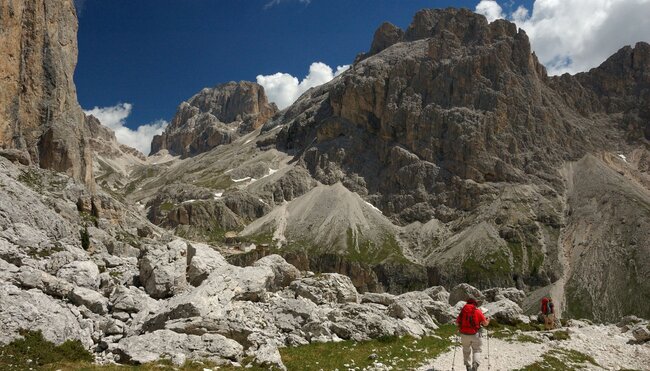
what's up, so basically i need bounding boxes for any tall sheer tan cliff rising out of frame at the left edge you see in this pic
[0,0,93,186]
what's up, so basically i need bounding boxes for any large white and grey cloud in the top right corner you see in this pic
[476,0,650,74]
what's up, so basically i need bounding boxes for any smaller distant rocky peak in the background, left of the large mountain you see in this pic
[151,81,277,157]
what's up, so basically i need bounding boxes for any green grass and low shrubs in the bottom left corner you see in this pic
[0,331,95,370]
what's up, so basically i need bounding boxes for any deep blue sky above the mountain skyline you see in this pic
[75,0,650,154]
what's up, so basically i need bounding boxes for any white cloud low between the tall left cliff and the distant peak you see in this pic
[84,103,168,154]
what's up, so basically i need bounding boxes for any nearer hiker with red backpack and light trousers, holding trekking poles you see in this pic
[456,298,490,371]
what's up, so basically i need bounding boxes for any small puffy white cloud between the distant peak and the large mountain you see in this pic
[257,62,350,109]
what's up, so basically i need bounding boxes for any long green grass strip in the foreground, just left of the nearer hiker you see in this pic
[280,325,456,371]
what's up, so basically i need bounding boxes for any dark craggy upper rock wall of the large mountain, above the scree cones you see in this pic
[272,9,605,223]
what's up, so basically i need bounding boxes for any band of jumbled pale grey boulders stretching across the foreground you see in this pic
[0,240,650,369]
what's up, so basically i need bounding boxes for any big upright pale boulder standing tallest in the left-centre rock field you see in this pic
[140,240,187,299]
